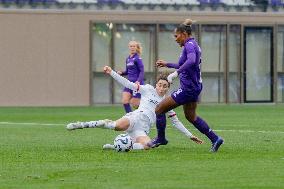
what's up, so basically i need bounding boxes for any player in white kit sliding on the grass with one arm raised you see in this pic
[66,66,203,150]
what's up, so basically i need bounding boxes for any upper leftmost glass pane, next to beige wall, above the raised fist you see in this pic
[92,23,113,72]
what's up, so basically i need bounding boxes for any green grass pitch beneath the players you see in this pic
[0,105,284,189]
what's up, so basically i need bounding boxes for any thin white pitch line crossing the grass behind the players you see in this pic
[0,122,284,134]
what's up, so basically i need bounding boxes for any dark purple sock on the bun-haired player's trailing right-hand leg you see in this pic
[192,117,218,143]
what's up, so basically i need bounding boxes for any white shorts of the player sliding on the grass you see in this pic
[123,111,151,141]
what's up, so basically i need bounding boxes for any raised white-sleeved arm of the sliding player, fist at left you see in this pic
[104,66,143,92]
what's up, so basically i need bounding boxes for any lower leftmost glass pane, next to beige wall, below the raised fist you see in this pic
[92,74,111,104]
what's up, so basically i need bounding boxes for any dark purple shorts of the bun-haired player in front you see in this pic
[171,88,201,105]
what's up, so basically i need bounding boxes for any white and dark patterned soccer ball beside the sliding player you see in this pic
[113,134,133,152]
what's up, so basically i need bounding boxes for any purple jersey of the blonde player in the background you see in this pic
[122,53,144,84]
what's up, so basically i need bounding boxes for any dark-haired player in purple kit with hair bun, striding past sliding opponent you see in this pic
[152,19,224,152]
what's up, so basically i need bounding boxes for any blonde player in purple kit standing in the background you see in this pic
[117,41,144,113]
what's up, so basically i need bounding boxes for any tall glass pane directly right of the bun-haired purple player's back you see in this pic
[201,25,226,102]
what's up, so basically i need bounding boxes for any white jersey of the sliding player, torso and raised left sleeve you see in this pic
[110,71,165,124]
